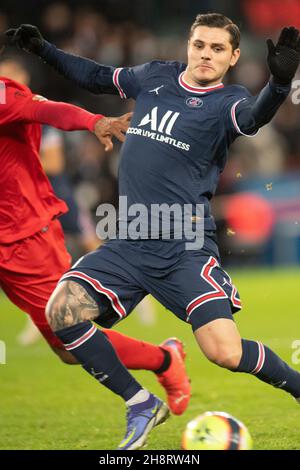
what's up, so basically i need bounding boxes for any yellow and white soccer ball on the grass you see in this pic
[181,411,252,450]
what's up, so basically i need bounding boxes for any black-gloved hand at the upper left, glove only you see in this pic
[5,24,45,54]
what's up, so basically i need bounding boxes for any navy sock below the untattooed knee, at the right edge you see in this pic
[235,339,300,398]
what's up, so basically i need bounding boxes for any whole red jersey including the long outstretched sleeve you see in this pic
[0,77,103,244]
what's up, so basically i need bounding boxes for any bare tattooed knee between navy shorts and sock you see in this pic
[46,281,100,331]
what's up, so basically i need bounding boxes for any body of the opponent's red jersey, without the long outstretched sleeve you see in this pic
[0,77,68,243]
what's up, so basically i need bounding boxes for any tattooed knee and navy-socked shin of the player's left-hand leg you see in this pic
[46,281,144,401]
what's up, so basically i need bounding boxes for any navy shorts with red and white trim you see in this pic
[60,235,241,331]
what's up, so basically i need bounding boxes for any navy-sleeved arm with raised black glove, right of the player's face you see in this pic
[236,26,300,134]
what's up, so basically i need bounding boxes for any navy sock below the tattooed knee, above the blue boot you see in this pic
[55,321,142,401]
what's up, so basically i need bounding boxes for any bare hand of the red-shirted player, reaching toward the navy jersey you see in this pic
[94,113,133,152]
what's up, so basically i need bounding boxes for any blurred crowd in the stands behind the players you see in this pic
[0,0,300,262]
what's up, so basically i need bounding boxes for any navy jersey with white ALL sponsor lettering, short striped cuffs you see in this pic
[113,61,254,229]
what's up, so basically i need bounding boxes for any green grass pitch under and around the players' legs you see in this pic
[0,270,300,450]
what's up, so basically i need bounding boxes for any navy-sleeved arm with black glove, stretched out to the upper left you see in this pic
[5,24,118,95]
